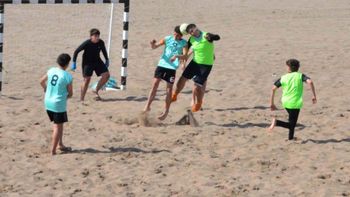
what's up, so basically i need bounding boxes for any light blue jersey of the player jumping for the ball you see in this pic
[158,36,187,70]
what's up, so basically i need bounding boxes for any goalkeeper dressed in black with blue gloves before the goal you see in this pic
[71,29,110,101]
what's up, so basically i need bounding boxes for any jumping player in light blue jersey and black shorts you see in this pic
[144,26,187,120]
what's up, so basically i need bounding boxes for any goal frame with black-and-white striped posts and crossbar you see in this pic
[0,0,130,95]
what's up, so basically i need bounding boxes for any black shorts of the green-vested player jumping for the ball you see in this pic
[182,60,212,86]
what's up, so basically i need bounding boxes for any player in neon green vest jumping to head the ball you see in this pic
[171,24,220,112]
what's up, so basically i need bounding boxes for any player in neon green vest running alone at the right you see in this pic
[269,59,317,140]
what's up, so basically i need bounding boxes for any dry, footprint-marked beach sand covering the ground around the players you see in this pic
[0,0,350,196]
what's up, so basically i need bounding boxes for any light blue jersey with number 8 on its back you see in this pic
[45,67,73,112]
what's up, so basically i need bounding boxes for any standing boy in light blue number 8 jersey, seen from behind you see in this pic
[40,54,73,155]
